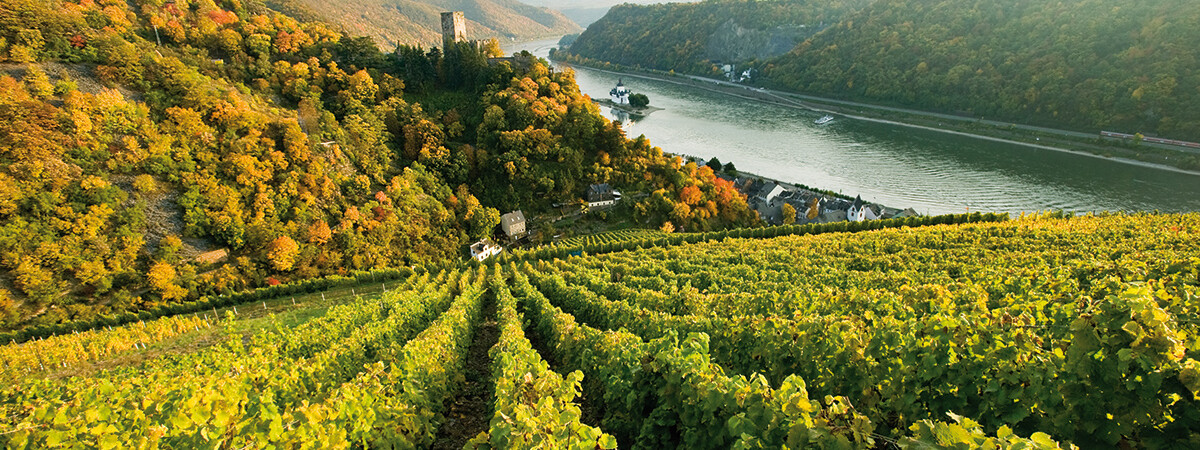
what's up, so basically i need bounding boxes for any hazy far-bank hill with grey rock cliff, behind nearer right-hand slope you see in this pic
[561,0,870,74]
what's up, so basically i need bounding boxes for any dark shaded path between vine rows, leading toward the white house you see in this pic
[433,293,500,450]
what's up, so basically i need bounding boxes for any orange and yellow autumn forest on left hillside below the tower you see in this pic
[0,0,752,329]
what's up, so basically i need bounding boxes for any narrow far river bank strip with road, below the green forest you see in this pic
[554,53,1200,176]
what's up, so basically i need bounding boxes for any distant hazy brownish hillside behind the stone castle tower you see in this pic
[273,0,582,49]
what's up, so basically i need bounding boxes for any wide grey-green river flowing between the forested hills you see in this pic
[505,40,1200,214]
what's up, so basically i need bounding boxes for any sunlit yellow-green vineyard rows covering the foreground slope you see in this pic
[0,215,1200,449]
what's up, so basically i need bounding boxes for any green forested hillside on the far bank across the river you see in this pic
[570,0,1200,140]
